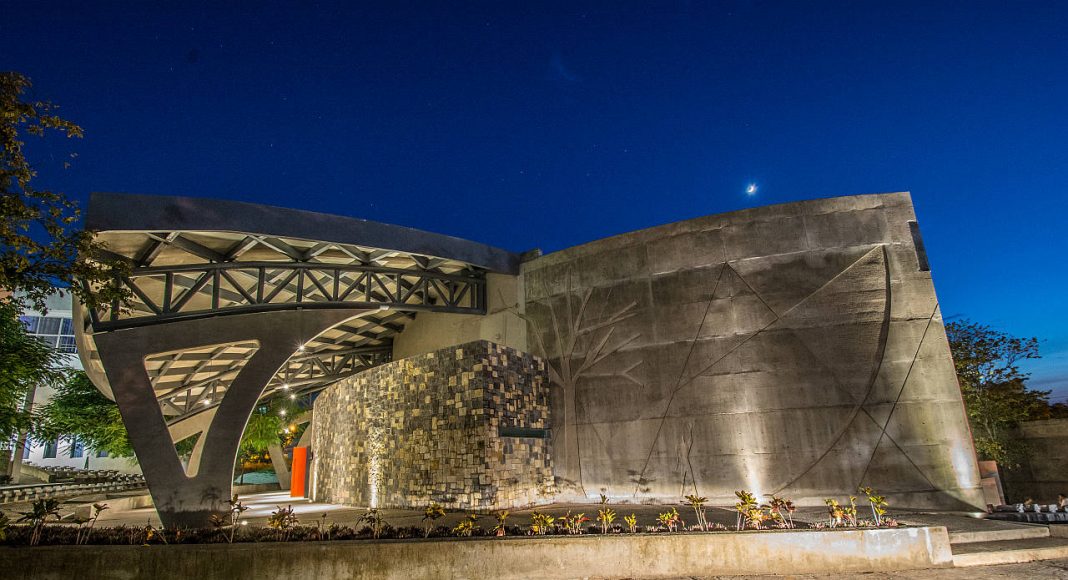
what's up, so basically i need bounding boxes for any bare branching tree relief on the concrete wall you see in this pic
[517,269,641,496]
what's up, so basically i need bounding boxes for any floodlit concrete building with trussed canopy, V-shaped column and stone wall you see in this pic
[76,193,983,523]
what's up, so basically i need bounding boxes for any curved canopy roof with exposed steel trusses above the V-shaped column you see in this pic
[78,193,519,422]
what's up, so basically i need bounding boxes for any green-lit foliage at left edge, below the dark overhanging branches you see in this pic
[0,300,64,441]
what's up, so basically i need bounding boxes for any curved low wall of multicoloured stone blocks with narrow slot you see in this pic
[312,341,553,510]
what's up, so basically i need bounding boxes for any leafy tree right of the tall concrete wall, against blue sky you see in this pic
[946,320,1050,469]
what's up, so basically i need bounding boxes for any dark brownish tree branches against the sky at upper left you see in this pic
[0,73,129,312]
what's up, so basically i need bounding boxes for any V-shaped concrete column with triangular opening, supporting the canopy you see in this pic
[94,310,361,527]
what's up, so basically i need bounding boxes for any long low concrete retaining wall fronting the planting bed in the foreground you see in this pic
[8,527,953,580]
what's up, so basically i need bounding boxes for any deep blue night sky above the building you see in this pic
[0,0,1068,398]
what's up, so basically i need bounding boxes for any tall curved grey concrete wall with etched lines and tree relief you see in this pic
[522,193,981,507]
